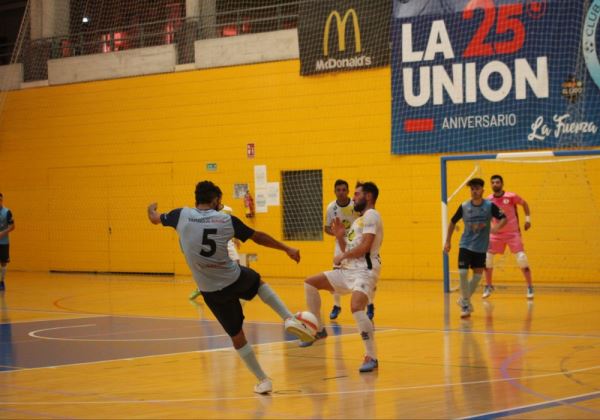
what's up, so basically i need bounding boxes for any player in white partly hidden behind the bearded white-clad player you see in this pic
[323,179,375,319]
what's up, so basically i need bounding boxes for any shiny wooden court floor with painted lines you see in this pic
[0,271,600,419]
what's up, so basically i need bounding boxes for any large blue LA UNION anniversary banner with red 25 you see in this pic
[391,0,600,154]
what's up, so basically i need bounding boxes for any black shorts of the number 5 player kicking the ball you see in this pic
[202,266,260,337]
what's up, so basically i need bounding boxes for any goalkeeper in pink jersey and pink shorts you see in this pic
[482,175,533,299]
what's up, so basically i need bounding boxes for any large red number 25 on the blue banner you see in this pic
[463,0,525,57]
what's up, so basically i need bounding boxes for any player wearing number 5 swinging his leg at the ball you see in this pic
[148,181,314,394]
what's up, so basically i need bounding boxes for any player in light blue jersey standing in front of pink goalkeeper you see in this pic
[444,178,507,318]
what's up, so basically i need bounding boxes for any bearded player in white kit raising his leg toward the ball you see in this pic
[304,182,383,372]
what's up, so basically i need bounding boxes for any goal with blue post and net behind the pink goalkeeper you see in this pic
[441,150,600,292]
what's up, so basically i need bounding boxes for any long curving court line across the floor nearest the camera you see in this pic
[0,365,600,406]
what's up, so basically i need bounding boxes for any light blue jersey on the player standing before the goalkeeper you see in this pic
[452,200,506,253]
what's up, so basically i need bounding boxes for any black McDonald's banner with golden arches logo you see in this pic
[298,0,392,75]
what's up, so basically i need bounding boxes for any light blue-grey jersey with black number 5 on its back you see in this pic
[160,207,254,292]
